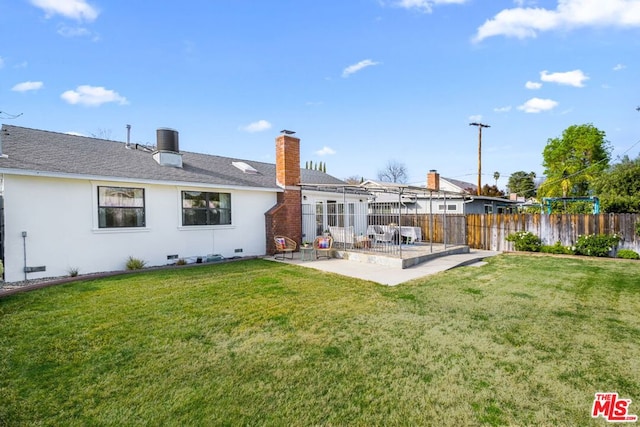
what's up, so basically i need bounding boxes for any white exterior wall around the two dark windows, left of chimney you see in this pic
[4,175,276,282]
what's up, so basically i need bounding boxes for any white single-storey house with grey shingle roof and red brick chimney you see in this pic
[0,125,366,282]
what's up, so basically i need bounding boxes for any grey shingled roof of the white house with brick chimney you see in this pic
[0,125,344,190]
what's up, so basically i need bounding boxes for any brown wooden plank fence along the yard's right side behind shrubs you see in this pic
[402,214,640,253]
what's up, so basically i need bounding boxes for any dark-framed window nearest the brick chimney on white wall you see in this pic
[182,191,231,226]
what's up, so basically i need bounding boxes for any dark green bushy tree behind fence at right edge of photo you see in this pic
[593,155,640,213]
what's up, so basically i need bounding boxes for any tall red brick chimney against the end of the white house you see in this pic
[265,131,302,255]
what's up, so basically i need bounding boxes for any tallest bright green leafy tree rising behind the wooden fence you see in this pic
[538,124,611,197]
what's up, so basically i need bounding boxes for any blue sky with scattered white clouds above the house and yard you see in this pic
[0,0,640,188]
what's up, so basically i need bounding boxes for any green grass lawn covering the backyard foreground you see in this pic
[0,255,640,426]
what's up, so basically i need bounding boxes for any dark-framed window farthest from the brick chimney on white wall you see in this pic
[98,187,145,228]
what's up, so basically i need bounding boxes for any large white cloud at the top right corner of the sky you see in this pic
[473,0,640,42]
